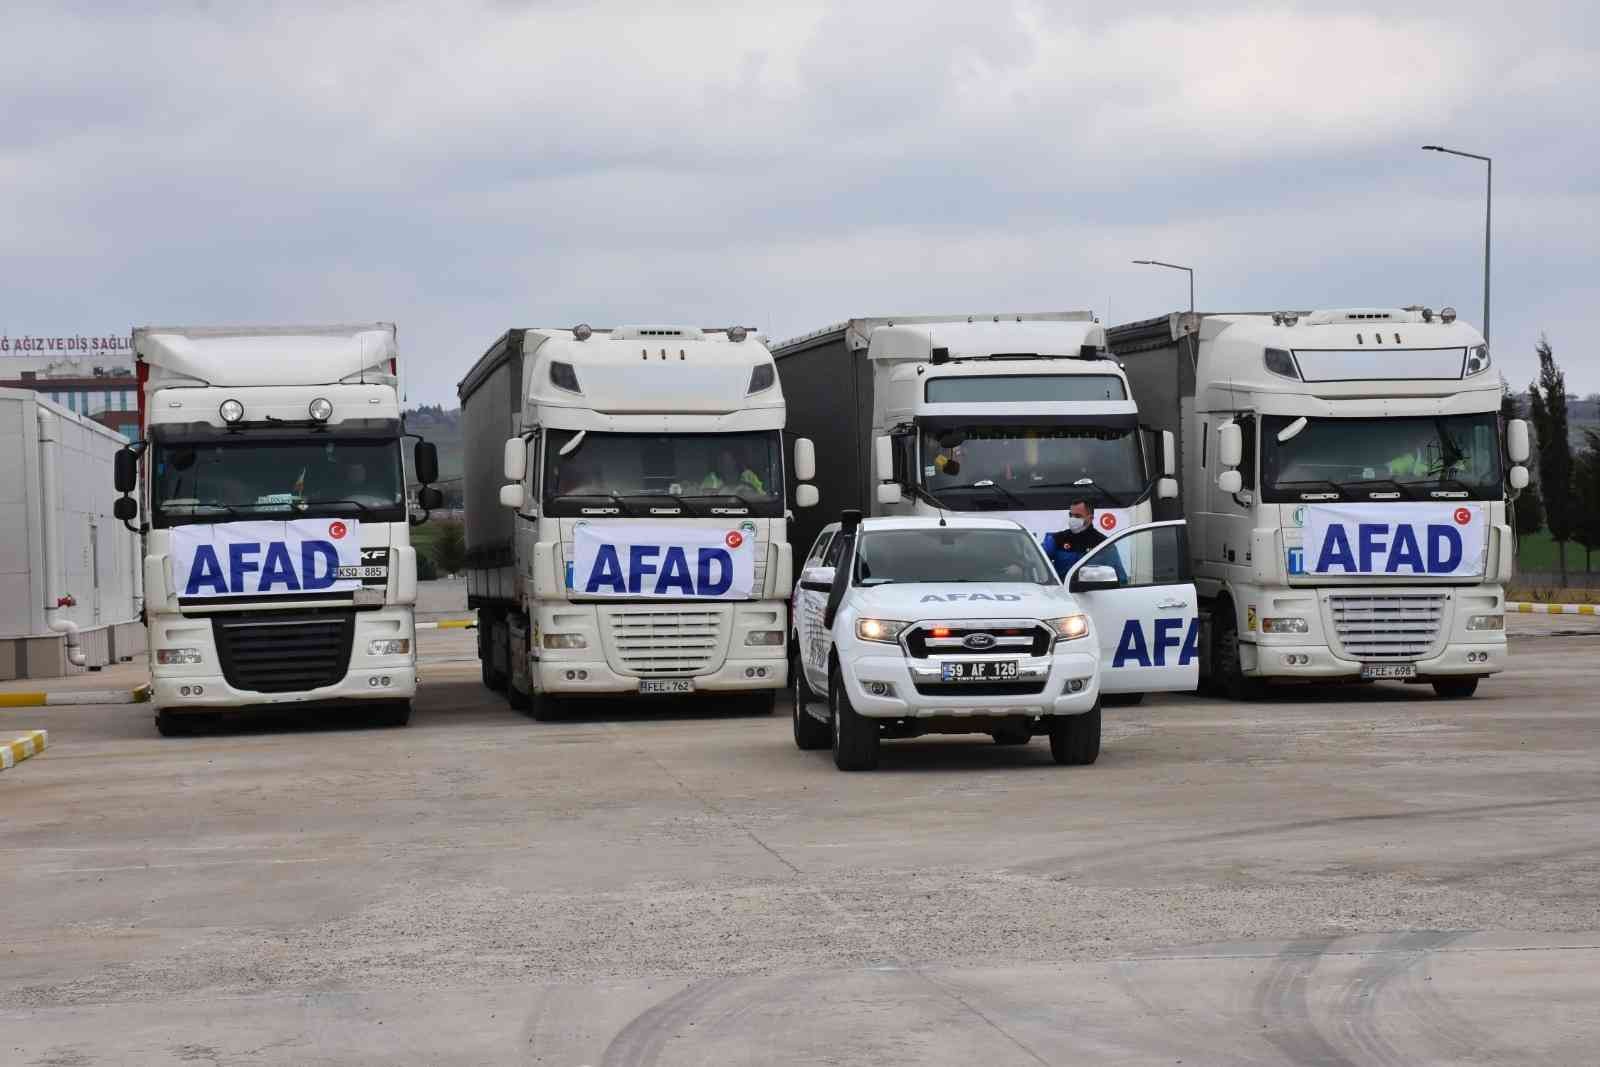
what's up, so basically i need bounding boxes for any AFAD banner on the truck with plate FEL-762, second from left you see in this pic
[566,522,757,600]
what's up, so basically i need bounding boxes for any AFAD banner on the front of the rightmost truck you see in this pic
[1302,504,1486,577]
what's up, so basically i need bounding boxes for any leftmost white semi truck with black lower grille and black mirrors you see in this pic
[115,323,438,734]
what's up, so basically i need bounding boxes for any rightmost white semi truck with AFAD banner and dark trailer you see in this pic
[1107,307,1528,699]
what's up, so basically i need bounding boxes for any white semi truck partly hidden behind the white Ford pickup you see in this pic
[773,312,1178,566]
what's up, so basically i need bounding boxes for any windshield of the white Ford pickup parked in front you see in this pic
[856,526,1058,585]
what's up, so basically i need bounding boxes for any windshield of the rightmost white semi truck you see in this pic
[1261,411,1504,502]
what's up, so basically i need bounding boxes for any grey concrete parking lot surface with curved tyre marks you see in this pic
[0,598,1600,1067]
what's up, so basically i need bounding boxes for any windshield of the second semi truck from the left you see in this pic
[544,430,784,518]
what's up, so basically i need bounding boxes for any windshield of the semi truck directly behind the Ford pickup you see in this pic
[920,424,1146,510]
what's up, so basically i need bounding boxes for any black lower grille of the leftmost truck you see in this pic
[211,611,355,693]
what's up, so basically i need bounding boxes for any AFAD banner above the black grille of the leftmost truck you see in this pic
[170,518,362,598]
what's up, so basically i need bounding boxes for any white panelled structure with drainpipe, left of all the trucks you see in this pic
[0,389,144,680]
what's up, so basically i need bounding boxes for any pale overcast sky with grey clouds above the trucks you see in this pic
[0,0,1600,405]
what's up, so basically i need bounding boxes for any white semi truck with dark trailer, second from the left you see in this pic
[459,325,816,720]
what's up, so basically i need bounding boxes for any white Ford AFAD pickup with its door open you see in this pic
[790,512,1200,771]
